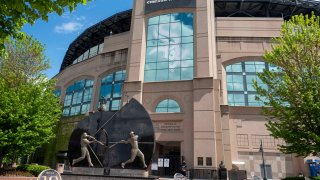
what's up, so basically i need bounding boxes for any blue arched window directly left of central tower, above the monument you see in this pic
[99,70,126,111]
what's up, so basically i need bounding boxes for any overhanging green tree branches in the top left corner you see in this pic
[0,0,90,49]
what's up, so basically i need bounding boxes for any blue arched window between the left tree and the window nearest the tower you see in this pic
[63,79,93,116]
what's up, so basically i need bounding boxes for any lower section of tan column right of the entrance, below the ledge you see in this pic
[193,77,216,169]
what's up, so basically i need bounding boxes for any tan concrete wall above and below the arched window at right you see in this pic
[216,17,307,179]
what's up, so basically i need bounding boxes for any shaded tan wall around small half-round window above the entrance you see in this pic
[143,81,194,163]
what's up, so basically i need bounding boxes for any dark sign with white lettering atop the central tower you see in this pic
[144,0,196,14]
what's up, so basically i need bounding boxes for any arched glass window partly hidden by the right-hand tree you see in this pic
[226,61,274,106]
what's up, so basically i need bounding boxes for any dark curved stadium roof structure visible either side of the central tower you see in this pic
[60,0,320,72]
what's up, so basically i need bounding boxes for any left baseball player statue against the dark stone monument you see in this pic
[72,132,104,167]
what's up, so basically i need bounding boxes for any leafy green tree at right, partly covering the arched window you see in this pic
[255,14,320,156]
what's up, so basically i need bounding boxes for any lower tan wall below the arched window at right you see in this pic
[225,107,307,179]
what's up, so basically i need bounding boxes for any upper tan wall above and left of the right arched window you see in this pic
[216,17,283,105]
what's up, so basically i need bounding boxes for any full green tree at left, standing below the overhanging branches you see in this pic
[0,36,61,164]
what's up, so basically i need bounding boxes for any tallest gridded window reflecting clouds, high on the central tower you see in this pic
[144,12,194,82]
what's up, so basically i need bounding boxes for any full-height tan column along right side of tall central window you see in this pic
[193,0,223,169]
